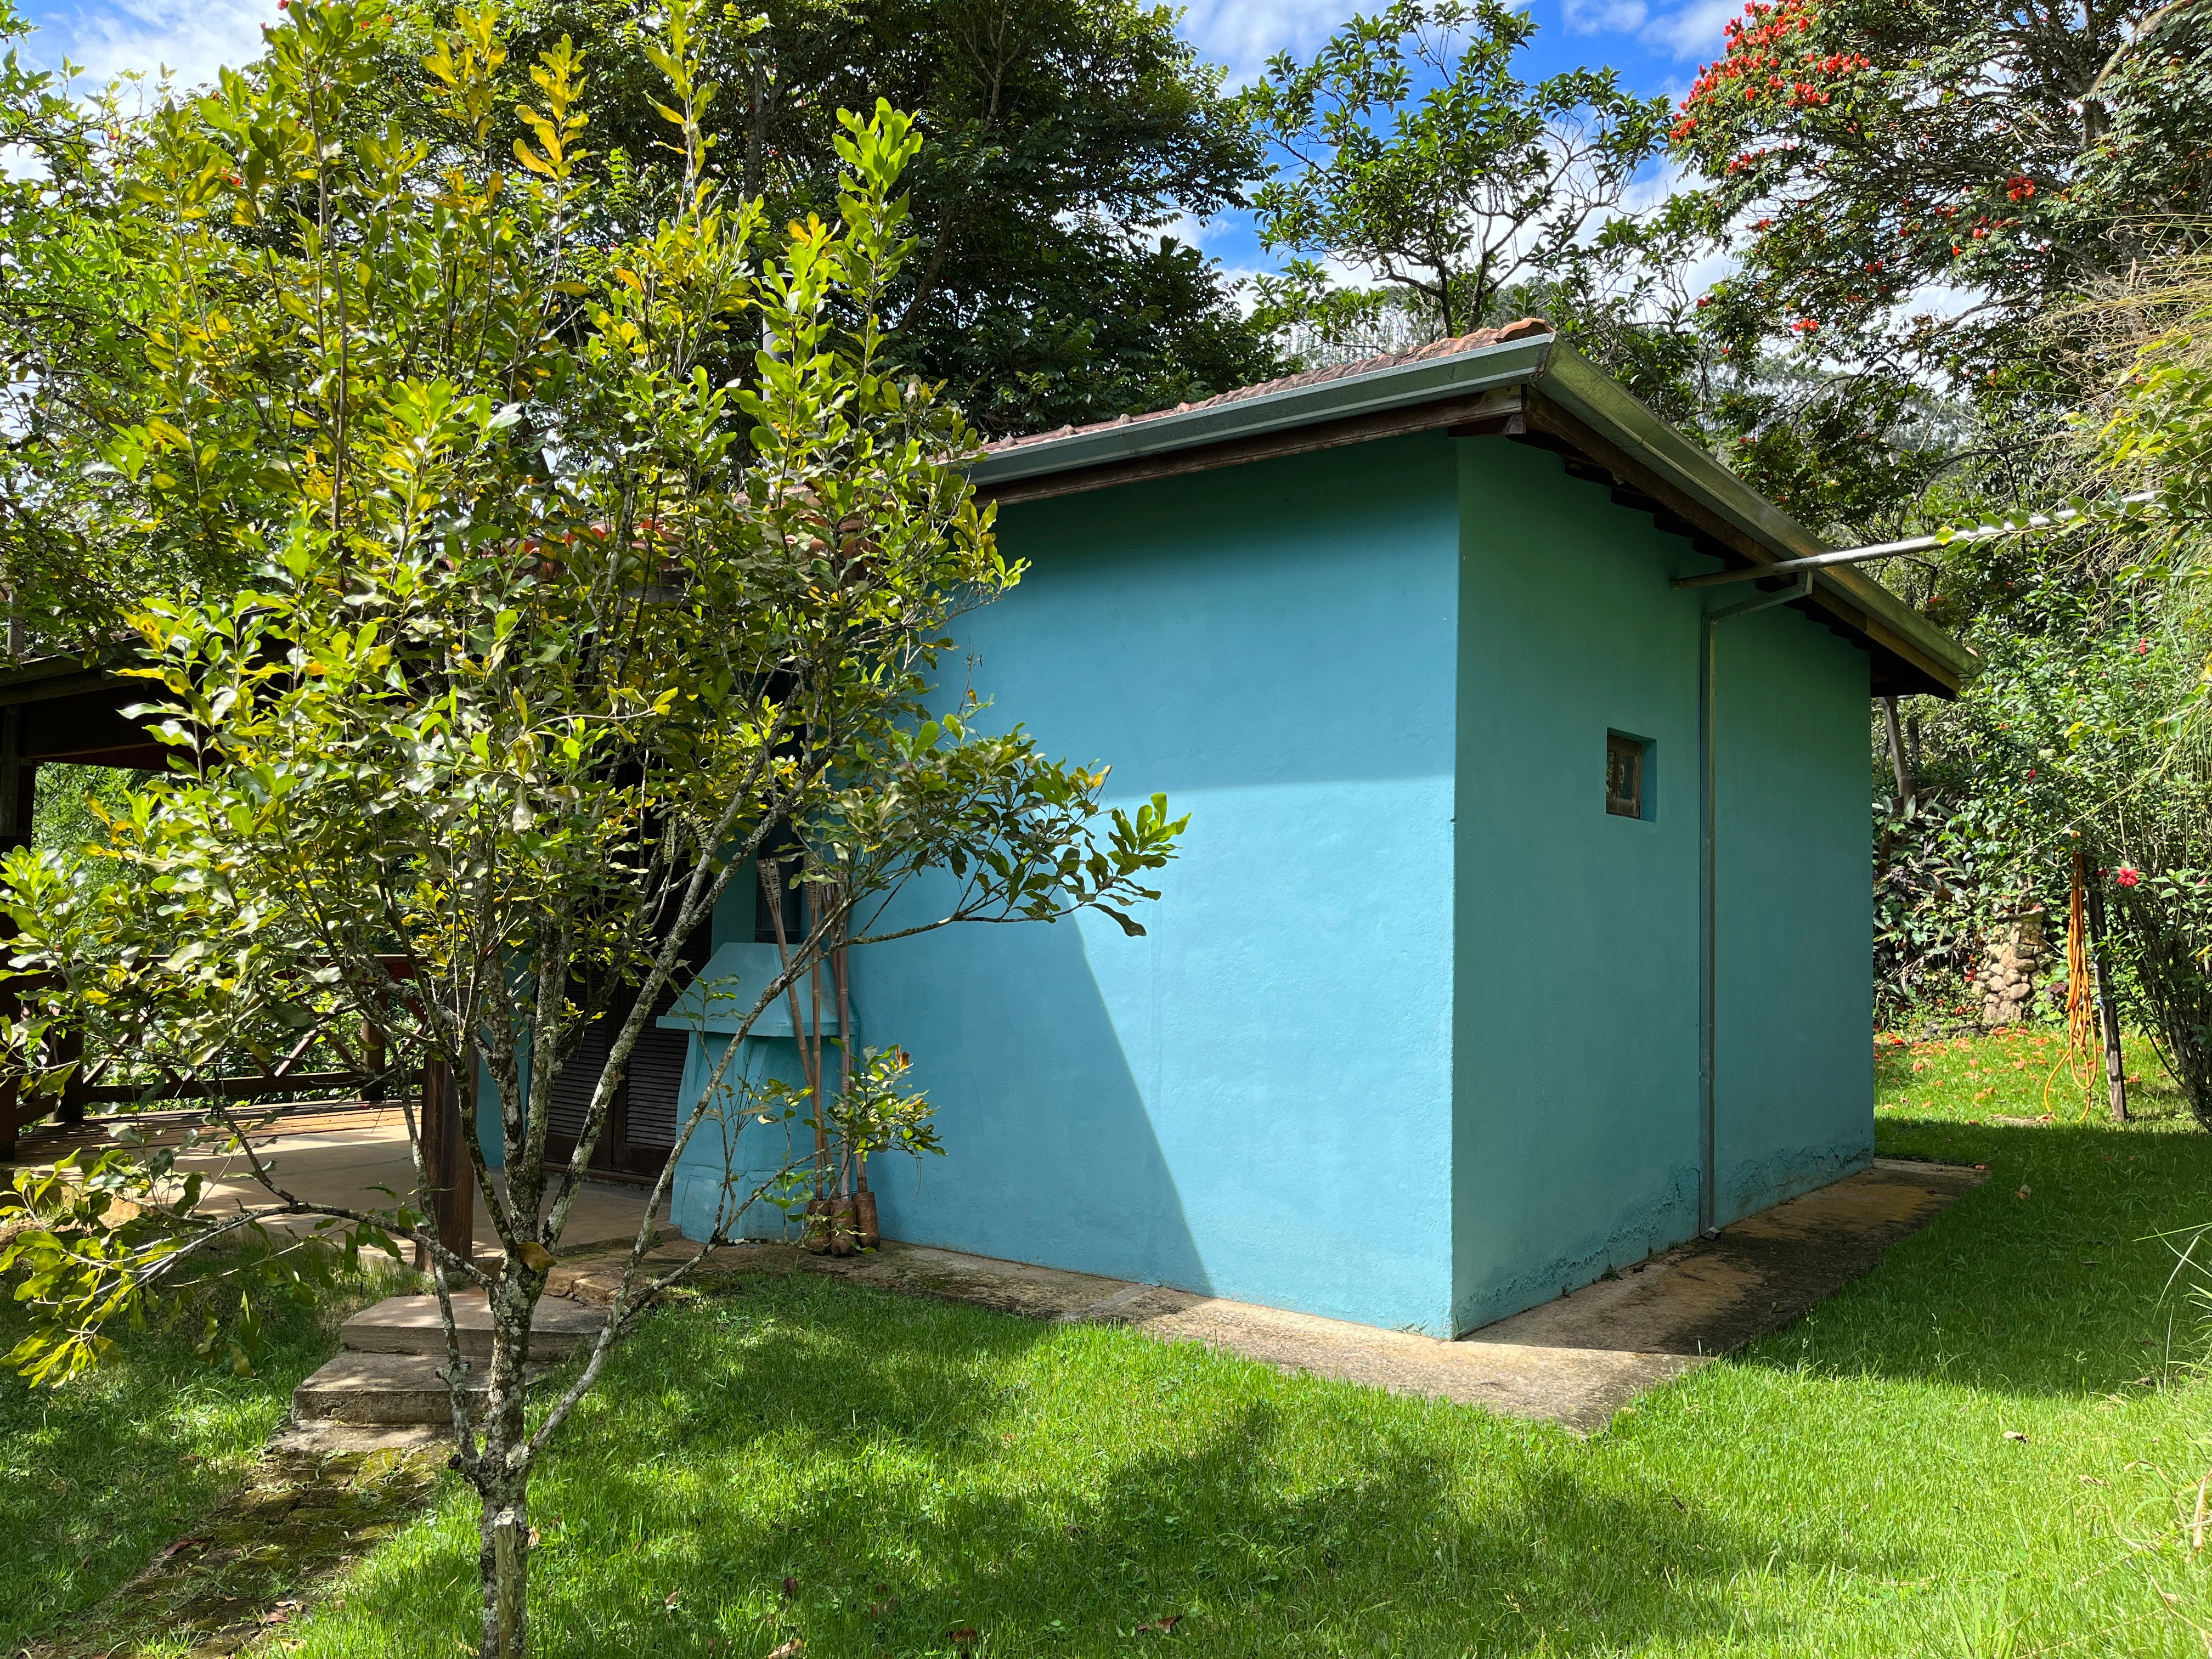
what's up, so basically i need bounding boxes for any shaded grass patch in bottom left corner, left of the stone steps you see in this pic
[0,1256,393,1655]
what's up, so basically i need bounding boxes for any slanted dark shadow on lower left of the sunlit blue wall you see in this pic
[854,894,1215,1294]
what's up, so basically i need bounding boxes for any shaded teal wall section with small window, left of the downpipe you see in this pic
[1453,438,1707,1329]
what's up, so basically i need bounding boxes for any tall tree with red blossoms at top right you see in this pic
[1670,0,2212,529]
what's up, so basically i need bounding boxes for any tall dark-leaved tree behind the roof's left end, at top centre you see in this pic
[484,0,1276,433]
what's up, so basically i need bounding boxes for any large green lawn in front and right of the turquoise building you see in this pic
[229,1040,2212,1659]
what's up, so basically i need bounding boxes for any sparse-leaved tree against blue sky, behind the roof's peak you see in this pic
[1243,0,1668,347]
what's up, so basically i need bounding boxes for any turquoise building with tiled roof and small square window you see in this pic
[646,323,1968,1336]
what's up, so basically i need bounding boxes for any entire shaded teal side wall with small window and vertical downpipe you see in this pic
[1453,440,1874,1329]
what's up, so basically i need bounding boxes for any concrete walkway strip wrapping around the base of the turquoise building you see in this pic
[571,1159,1982,1434]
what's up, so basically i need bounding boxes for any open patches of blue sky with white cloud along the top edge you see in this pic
[26,0,1741,272]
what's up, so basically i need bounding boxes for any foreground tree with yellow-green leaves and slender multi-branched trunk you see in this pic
[0,0,1181,1659]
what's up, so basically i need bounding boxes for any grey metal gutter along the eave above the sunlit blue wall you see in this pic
[969,334,1555,489]
